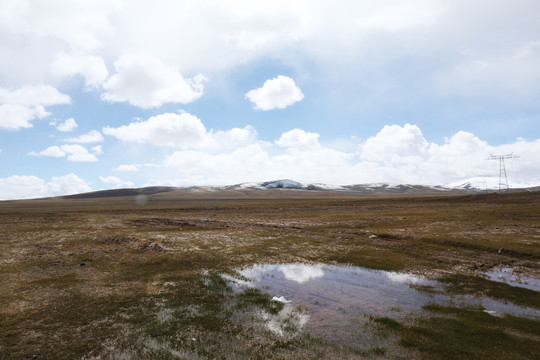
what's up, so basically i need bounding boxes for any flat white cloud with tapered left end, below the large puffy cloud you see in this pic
[103,113,206,148]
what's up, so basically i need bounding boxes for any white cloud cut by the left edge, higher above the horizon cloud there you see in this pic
[0,84,71,130]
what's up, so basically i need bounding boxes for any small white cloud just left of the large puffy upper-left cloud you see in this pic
[51,52,109,90]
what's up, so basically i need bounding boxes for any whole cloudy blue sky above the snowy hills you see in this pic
[0,0,540,199]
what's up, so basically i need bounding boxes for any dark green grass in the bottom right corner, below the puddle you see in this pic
[373,304,540,360]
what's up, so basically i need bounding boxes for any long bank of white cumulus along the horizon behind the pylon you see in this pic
[153,124,540,186]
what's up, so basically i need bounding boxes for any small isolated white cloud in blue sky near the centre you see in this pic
[246,75,304,111]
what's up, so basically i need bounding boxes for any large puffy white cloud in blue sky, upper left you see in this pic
[101,54,206,109]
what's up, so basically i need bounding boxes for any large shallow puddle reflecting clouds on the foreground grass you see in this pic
[224,264,540,345]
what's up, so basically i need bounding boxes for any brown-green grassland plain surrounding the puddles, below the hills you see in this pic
[0,190,540,360]
